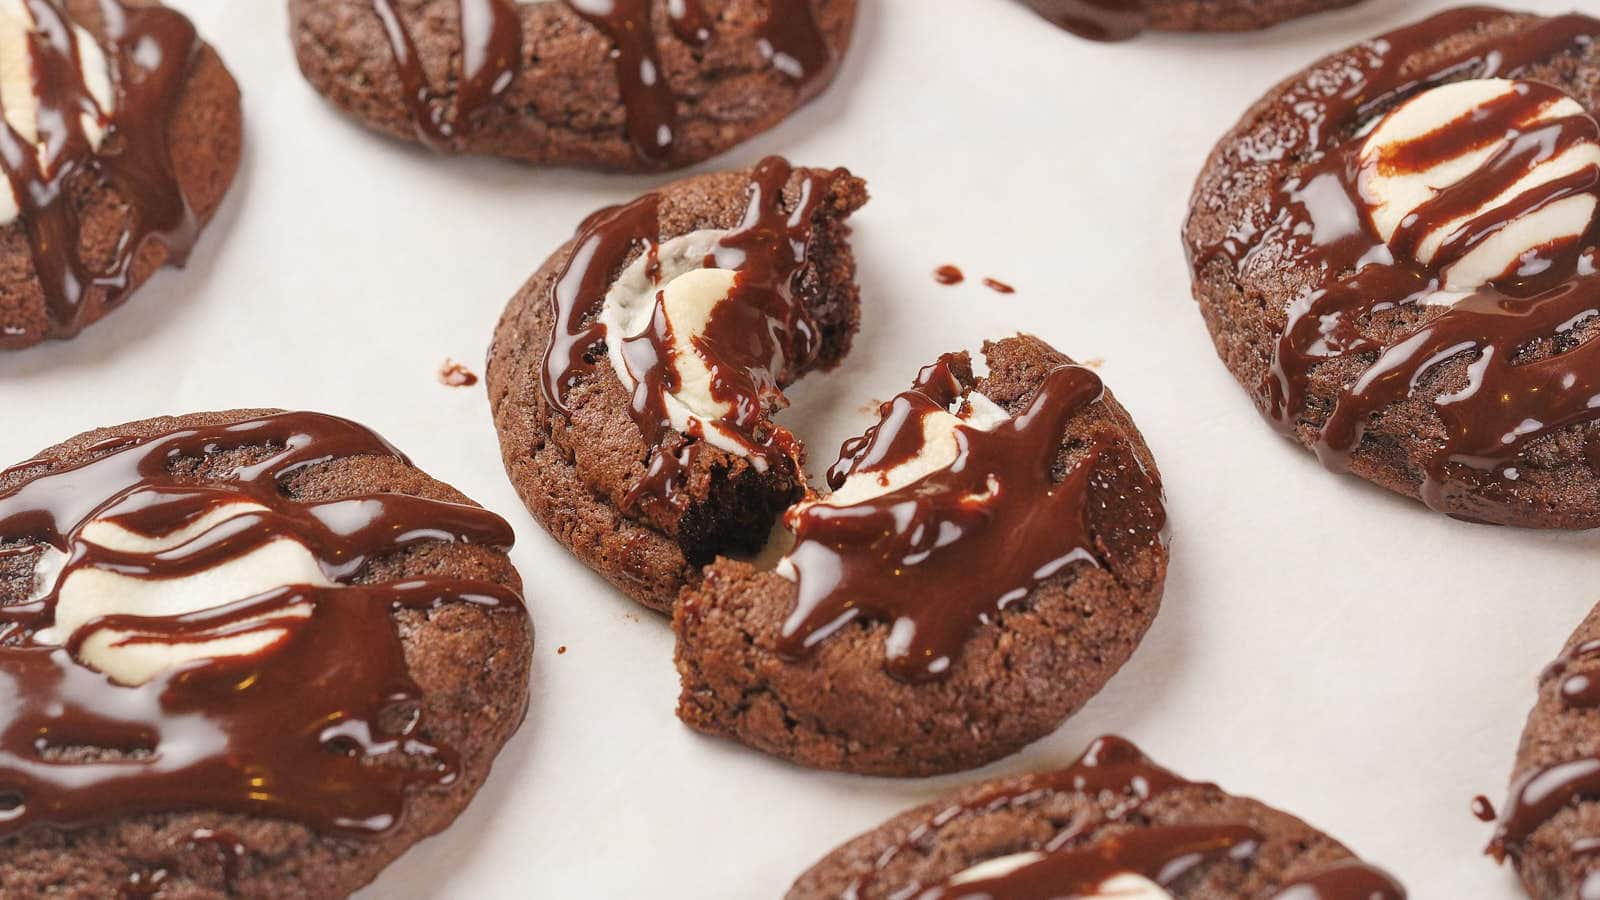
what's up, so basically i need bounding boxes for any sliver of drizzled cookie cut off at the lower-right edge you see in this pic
[1490,595,1600,897]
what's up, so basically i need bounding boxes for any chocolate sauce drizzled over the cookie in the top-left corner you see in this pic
[0,0,200,346]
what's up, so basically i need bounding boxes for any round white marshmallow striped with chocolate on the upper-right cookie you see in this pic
[1360,78,1600,291]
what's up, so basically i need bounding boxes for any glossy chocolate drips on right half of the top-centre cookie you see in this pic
[566,0,837,162]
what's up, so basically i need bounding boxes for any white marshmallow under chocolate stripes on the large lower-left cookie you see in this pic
[37,501,333,684]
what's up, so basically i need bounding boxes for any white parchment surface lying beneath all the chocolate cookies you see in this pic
[0,0,1600,898]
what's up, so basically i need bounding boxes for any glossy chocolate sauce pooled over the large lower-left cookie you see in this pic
[0,413,526,832]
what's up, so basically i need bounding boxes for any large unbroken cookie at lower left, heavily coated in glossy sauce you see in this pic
[0,410,531,898]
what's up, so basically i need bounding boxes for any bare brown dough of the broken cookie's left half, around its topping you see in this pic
[486,160,867,612]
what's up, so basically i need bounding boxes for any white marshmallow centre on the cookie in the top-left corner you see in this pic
[0,0,115,224]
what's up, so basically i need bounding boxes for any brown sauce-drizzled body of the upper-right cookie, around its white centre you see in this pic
[1184,6,1600,528]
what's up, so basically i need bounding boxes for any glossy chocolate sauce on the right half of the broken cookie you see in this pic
[778,356,1160,682]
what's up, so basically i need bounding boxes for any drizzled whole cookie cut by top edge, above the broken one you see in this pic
[290,0,856,171]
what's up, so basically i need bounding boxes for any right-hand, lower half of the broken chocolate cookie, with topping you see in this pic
[672,336,1168,775]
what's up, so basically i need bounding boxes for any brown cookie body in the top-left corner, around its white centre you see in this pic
[0,0,243,349]
